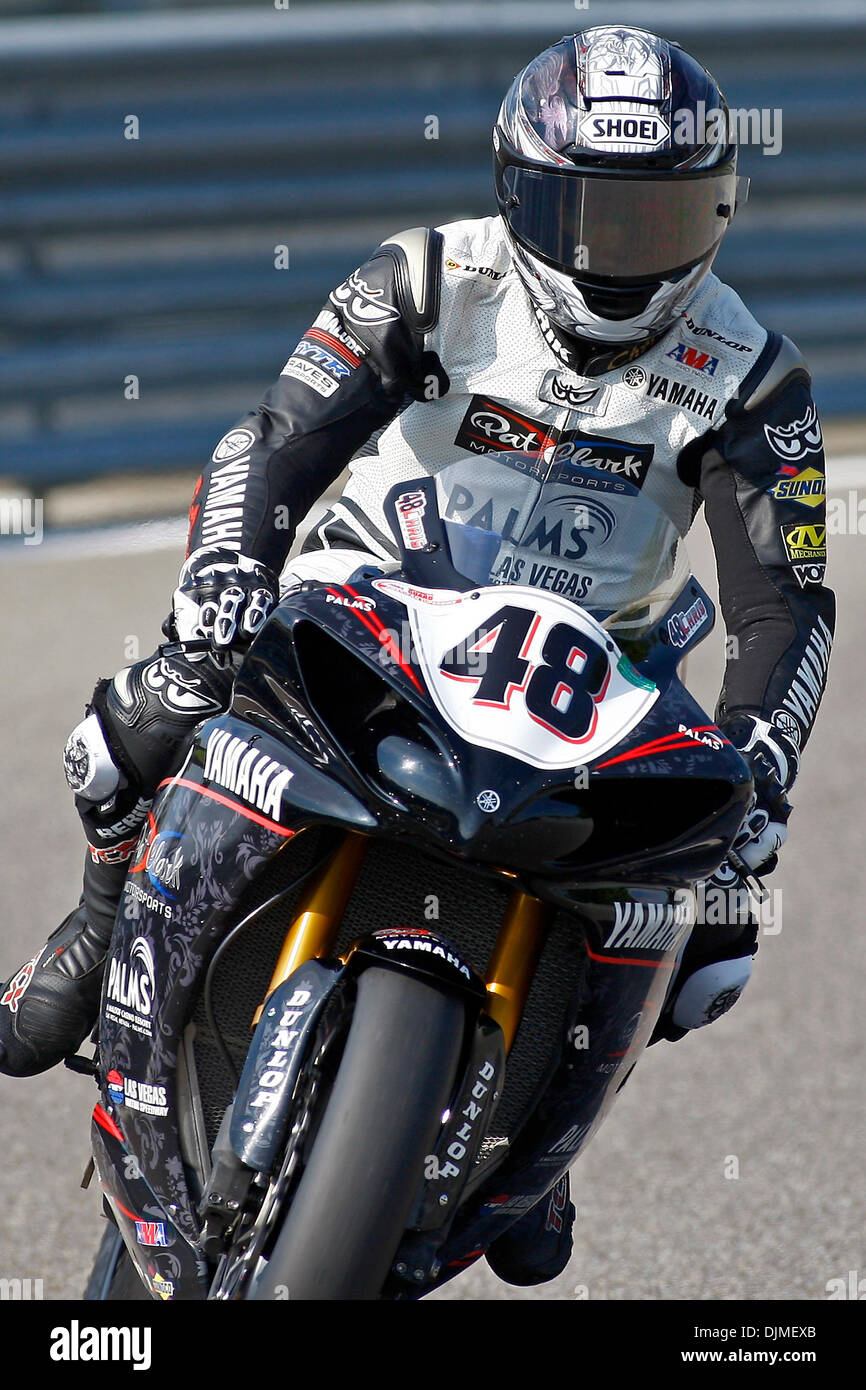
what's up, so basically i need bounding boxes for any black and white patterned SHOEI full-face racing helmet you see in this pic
[493,25,748,343]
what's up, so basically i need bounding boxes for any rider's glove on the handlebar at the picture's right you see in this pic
[721,714,799,874]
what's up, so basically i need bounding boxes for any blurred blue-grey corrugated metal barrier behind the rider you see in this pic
[0,0,866,489]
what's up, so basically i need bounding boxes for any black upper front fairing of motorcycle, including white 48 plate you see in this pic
[234,478,751,902]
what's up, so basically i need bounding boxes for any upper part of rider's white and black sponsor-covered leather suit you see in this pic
[189,217,834,748]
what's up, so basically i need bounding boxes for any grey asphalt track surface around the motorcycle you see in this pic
[0,472,866,1301]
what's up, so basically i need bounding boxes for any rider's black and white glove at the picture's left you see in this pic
[170,546,279,653]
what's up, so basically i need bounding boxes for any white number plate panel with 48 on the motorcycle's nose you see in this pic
[403,585,659,767]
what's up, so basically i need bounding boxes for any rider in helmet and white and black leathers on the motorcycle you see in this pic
[0,26,834,1283]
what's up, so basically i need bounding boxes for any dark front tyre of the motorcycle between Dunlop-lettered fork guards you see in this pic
[247,967,464,1300]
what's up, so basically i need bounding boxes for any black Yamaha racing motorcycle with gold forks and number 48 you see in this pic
[85,455,752,1300]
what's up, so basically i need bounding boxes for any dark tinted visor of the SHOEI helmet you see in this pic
[500,164,748,281]
